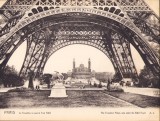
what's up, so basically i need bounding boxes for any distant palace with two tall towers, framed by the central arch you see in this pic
[72,59,92,79]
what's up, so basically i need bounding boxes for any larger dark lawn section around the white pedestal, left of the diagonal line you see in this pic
[0,90,134,108]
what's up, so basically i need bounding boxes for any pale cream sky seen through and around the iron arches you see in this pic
[0,0,159,73]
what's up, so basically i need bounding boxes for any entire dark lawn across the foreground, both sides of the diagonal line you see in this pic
[0,90,160,108]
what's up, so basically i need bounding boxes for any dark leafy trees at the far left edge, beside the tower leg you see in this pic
[0,66,24,87]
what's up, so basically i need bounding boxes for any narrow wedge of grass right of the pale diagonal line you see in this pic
[103,91,160,108]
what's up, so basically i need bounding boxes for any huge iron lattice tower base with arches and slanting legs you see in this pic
[0,0,159,79]
